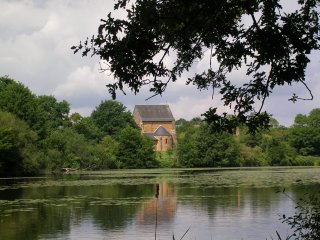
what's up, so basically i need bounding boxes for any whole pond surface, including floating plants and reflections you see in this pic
[0,168,320,240]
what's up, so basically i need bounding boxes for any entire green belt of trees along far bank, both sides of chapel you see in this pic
[0,76,320,176]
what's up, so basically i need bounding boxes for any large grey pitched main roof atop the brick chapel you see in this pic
[134,105,174,122]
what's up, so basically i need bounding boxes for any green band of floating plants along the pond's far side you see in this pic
[0,167,320,191]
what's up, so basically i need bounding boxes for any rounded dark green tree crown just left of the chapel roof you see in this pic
[91,100,136,135]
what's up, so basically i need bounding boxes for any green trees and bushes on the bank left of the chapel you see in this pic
[0,77,158,176]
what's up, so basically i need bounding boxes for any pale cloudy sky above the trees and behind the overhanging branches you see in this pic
[0,0,320,126]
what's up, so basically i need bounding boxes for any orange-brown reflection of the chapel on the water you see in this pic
[136,182,177,225]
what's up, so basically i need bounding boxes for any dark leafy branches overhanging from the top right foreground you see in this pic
[71,0,319,131]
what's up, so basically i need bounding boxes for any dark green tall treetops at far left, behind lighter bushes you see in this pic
[0,77,70,139]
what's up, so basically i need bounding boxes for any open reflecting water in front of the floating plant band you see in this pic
[0,170,319,240]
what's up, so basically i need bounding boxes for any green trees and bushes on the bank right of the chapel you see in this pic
[177,112,320,167]
